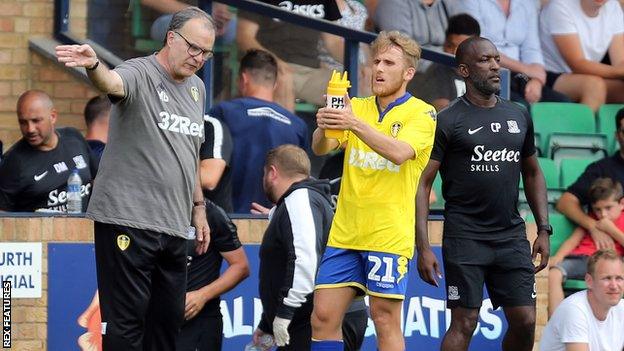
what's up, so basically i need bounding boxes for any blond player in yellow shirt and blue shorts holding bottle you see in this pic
[311,31,435,351]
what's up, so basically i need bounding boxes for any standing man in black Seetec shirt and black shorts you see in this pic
[416,37,552,351]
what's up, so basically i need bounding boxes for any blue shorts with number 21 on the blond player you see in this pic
[316,246,410,300]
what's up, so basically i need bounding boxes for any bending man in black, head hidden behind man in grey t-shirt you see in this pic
[176,200,249,351]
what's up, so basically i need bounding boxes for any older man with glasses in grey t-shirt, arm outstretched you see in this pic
[56,7,210,350]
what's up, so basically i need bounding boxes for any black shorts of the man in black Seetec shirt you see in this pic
[442,236,536,309]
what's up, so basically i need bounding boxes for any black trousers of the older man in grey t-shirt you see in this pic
[95,222,186,351]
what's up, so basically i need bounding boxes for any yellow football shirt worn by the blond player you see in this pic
[328,94,436,258]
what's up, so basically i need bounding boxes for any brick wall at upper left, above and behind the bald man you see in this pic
[0,0,96,150]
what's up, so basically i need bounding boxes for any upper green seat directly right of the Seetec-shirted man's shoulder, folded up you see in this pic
[531,102,608,164]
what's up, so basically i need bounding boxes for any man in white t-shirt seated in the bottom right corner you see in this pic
[539,249,624,351]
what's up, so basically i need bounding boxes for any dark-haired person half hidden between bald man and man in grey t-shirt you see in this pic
[84,95,111,165]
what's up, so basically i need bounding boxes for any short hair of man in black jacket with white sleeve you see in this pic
[265,144,311,177]
